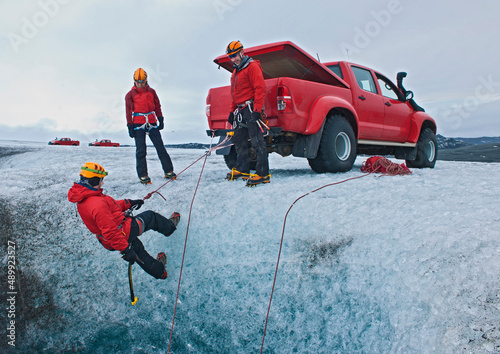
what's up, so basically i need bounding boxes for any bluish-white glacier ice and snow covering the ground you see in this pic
[0,141,500,353]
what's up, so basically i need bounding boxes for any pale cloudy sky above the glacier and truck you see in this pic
[0,0,500,144]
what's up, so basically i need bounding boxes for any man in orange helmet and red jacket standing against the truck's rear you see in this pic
[226,41,271,186]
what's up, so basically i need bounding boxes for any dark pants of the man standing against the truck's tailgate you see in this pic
[233,106,269,177]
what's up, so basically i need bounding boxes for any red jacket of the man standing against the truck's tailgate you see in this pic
[230,60,266,112]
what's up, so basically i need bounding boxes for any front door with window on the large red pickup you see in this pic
[376,73,413,142]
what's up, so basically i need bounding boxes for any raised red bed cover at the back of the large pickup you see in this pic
[214,41,349,88]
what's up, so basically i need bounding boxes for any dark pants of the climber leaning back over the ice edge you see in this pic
[128,210,176,279]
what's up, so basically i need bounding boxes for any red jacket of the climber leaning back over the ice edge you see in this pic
[68,183,132,251]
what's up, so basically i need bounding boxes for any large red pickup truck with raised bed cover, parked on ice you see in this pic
[206,42,437,173]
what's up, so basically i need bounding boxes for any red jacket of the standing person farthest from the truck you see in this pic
[125,86,163,125]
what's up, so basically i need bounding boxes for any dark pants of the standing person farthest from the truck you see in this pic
[134,125,174,177]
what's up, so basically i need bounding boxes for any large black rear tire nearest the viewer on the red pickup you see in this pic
[307,114,356,173]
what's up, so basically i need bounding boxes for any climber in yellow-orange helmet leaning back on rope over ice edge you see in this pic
[68,162,181,279]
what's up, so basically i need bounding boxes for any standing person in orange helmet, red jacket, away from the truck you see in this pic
[125,68,177,184]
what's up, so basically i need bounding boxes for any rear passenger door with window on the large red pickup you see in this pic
[351,66,384,139]
